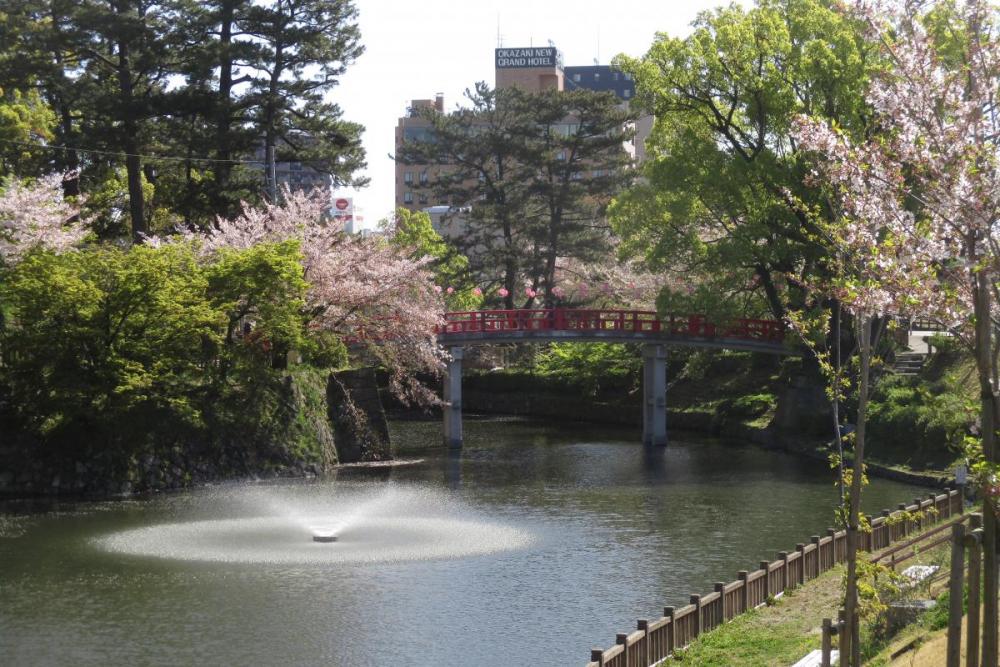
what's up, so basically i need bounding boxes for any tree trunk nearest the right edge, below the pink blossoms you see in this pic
[973,270,1000,667]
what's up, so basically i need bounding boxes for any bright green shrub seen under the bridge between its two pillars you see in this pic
[536,343,642,397]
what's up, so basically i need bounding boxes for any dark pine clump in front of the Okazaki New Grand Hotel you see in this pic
[396,83,631,308]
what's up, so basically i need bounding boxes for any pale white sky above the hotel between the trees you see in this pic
[330,0,736,227]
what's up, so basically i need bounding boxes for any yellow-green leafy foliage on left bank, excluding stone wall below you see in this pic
[0,242,332,464]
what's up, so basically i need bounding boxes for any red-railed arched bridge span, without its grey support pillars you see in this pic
[438,308,788,354]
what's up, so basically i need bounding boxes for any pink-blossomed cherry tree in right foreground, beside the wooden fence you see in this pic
[798,0,1000,667]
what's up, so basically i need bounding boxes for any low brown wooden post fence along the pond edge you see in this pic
[587,489,962,667]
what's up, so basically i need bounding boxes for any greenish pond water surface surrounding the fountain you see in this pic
[0,420,923,665]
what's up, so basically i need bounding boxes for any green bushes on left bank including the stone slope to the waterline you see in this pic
[0,241,346,494]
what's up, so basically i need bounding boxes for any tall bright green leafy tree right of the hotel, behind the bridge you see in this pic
[612,0,872,318]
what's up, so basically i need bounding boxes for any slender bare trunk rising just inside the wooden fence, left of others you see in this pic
[842,315,872,667]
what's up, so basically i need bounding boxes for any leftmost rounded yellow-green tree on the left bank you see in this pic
[0,245,219,446]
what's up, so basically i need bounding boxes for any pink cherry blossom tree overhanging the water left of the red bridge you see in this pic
[185,190,444,404]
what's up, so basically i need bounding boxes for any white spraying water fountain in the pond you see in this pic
[95,483,531,565]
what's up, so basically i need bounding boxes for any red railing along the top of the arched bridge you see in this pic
[439,308,785,343]
